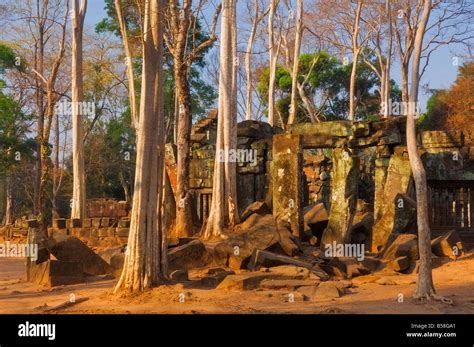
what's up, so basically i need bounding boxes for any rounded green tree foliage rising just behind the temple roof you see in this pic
[257,52,401,121]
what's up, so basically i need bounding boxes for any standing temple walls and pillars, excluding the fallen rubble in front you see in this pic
[180,112,474,253]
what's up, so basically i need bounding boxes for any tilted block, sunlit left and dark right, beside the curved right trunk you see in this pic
[372,194,416,252]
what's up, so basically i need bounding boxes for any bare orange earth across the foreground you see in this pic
[0,254,474,314]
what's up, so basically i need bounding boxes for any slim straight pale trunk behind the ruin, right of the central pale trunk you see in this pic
[268,0,279,126]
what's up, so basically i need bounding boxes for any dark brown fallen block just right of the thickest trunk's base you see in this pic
[168,240,211,270]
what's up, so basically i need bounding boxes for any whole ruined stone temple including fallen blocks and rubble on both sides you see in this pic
[1,111,474,296]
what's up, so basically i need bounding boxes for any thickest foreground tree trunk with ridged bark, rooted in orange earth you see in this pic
[114,0,167,292]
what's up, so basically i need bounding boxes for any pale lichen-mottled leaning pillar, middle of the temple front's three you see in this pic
[321,148,360,248]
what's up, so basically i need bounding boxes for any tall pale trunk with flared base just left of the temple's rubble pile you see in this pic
[203,0,239,239]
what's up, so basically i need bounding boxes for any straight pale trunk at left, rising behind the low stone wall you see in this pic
[71,0,87,219]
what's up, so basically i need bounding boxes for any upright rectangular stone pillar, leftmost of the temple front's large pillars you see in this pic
[272,135,303,236]
